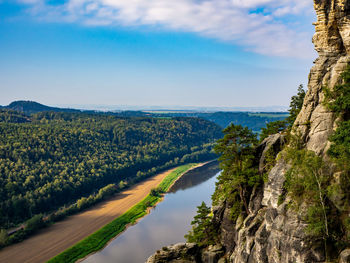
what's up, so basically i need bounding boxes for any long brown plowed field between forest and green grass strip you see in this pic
[0,168,175,263]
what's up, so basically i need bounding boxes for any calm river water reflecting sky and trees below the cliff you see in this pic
[83,164,219,263]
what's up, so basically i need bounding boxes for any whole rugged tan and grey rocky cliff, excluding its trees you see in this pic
[148,0,350,263]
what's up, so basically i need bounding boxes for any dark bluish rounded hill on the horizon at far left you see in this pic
[3,100,80,115]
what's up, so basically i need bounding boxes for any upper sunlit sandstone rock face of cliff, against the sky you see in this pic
[295,0,350,154]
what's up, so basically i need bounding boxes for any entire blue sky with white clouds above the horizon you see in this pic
[0,0,316,107]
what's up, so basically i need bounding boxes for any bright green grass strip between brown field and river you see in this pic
[48,164,196,263]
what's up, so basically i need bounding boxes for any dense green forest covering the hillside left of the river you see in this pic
[0,110,222,231]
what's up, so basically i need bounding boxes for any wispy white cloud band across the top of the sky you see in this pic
[14,0,314,58]
